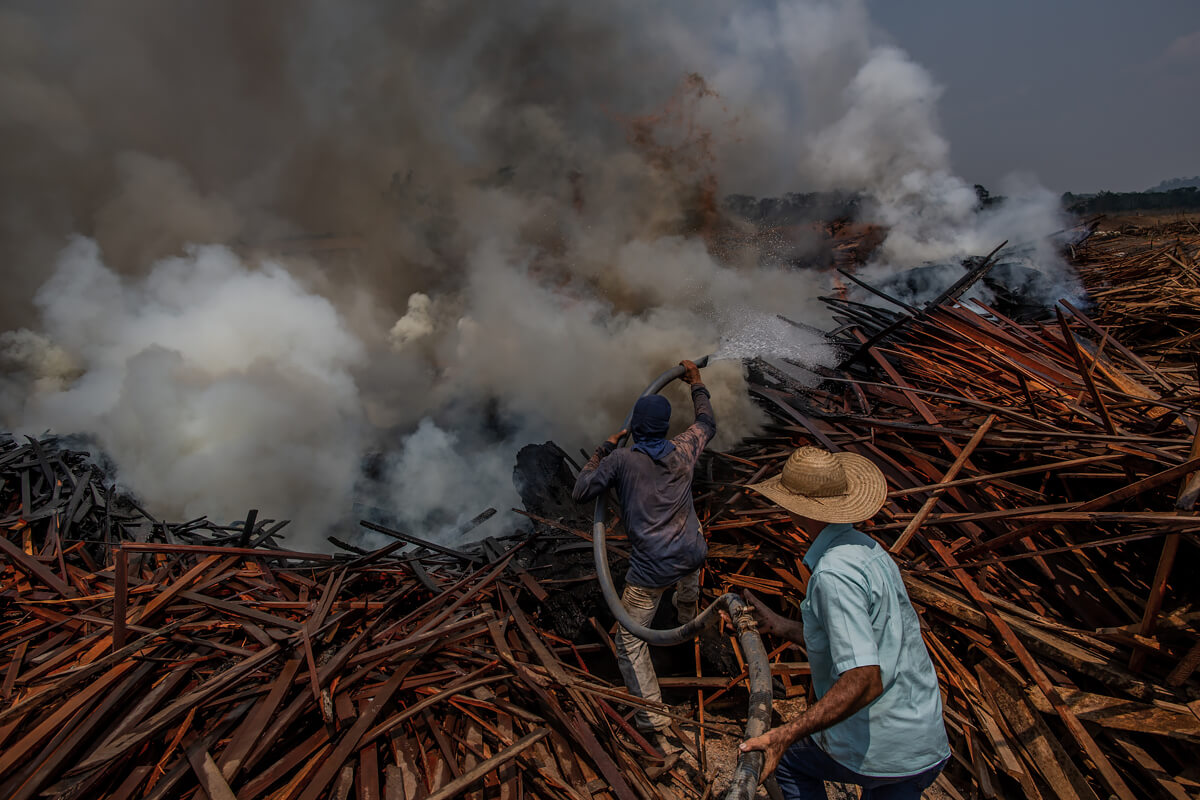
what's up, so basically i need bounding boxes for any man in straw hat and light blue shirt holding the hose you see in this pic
[742,447,950,800]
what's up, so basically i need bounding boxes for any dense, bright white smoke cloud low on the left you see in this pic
[0,237,365,546]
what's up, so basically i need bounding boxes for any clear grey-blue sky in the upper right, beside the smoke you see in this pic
[868,0,1200,192]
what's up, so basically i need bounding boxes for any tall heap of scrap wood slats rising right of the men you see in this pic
[697,291,1200,798]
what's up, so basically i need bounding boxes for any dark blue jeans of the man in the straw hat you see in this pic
[775,736,946,800]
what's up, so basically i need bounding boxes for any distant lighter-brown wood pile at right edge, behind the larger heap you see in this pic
[1073,221,1200,368]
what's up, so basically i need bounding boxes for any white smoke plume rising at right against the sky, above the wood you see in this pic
[792,28,1080,299]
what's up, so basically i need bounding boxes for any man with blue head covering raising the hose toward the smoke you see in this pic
[572,361,716,754]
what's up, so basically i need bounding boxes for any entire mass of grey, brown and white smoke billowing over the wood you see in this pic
[0,0,1058,546]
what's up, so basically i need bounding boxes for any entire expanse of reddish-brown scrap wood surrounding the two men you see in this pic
[0,219,1200,800]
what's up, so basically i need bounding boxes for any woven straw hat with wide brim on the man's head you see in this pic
[750,447,888,522]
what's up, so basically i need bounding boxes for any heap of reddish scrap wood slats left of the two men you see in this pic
[0,448,710,800]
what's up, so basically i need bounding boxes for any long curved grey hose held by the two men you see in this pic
[592,355,772,800]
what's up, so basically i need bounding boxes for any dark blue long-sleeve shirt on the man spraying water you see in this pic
[572,384,716,588]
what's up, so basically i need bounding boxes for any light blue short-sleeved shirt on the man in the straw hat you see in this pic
[800,525,950,777]
